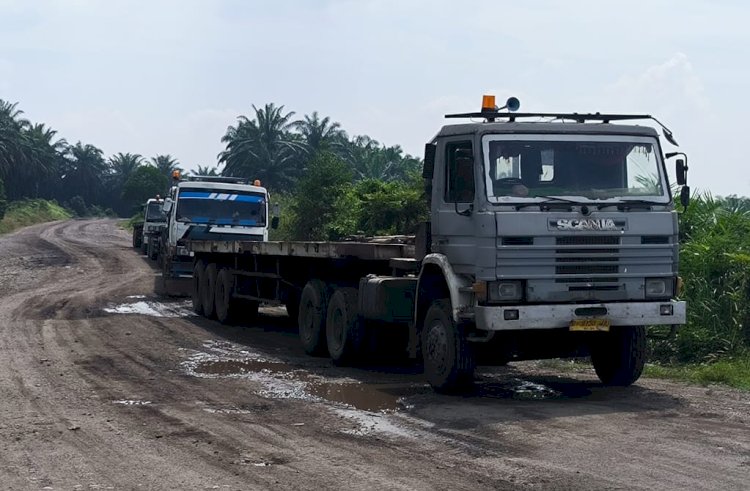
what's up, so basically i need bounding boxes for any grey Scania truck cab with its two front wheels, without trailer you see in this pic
[415,98,689,387]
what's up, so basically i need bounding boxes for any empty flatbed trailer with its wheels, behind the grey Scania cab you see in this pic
[185,236,420,363]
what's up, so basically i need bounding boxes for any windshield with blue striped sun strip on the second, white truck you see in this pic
[176,188,266,227]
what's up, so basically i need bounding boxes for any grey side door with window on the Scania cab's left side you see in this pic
[432,137,476,274]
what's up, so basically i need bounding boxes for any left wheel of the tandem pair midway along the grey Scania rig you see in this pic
[297,279,329,356]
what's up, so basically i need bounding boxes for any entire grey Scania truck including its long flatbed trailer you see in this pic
[183,96,689,391]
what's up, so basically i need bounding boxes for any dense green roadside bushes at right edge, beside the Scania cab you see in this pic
[651,194,750,363]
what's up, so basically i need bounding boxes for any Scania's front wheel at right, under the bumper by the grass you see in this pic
[591,326,646,386]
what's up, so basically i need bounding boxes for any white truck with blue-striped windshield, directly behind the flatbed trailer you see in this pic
[159,172,278,293]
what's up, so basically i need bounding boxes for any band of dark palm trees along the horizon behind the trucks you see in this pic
[0,99,421,223]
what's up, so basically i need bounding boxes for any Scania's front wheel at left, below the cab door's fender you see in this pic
[422,299,474,392]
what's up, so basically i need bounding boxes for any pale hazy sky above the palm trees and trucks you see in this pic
[0,0,750,196]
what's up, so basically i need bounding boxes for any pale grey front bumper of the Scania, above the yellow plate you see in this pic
[474,300,686,331]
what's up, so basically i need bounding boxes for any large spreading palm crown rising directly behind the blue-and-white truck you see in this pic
[219,103,305,190]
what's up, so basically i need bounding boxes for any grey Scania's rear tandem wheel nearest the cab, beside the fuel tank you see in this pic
[326,288,364,365]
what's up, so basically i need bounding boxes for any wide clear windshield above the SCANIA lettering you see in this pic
[483,135,669,203]
